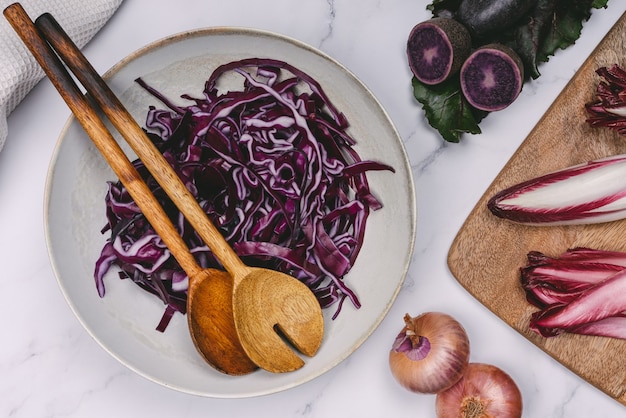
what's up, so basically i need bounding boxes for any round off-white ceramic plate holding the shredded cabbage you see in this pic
[46,28,416,398]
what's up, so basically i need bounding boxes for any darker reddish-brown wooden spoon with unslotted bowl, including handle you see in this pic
[4,5,258,375]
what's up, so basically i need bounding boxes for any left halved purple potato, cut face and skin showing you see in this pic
[407,17,471,84]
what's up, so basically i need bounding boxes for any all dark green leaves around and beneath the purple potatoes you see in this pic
[412,0,608,142]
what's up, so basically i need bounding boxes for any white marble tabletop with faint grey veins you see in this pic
[0,0,626,418]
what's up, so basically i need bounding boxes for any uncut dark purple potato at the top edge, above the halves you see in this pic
[456,0,537,38]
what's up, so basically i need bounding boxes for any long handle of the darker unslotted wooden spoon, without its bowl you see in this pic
[4,3,201,277]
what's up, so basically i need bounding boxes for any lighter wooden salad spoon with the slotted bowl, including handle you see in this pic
[5,3,324,373]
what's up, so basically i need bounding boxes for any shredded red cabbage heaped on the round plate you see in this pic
[94,58,394,331]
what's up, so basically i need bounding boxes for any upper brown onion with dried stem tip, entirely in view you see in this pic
[389,312,470,393]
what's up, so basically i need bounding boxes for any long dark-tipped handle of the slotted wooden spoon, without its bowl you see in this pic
[35,13,247,276]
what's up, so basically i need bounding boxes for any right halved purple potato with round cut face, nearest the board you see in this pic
[460,44,524,112]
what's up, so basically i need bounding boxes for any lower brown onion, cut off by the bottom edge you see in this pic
[435,363,522,418]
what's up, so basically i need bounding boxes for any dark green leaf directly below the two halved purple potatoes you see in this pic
[413,77,487,142]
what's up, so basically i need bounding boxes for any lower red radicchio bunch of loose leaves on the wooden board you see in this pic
[521,248,626,339]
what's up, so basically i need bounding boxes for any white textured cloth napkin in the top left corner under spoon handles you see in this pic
[0,0,122,150]
